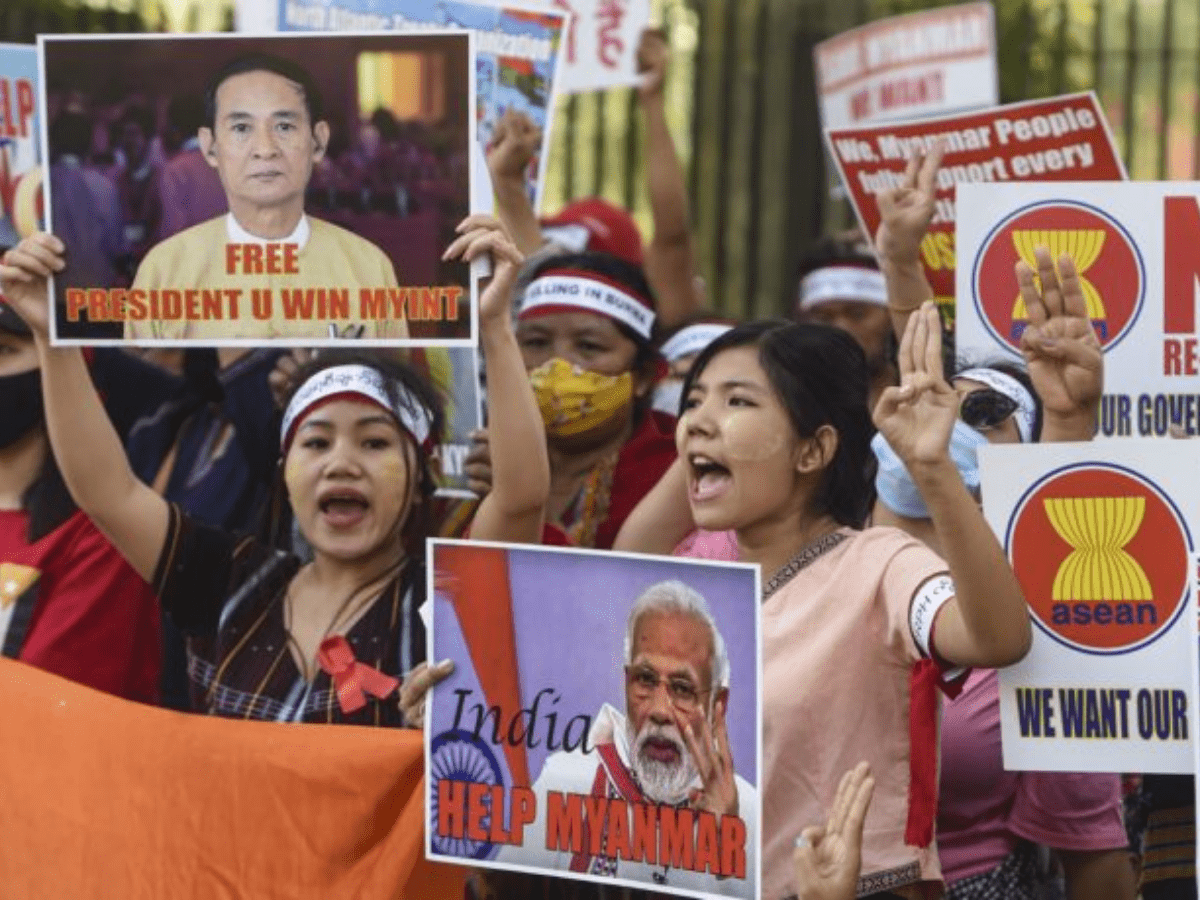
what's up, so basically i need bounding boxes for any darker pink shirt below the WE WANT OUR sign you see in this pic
[937,670,1128,883]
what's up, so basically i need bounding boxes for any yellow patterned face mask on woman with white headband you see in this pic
[529,356,634,438]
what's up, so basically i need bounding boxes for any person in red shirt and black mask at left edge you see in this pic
[0,294,158,703]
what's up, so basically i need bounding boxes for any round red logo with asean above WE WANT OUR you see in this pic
[1006,462,1192,654]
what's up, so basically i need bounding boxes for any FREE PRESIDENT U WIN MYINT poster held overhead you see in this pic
[40,34,473,346]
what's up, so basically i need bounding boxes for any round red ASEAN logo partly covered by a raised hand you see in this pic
[971,200,1146,350]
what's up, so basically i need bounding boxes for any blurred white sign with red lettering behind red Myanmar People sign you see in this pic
[812,2,1000,128]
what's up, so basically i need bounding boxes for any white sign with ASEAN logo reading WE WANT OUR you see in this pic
[979,440,1200,773]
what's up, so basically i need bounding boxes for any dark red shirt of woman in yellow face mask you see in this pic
[541,409,676,550]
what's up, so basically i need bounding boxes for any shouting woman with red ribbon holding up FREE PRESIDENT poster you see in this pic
[0,217,548,726]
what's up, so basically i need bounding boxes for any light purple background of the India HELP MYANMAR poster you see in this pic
[431,550,758,785]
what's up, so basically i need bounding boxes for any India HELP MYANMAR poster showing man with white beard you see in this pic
[426,541,762,898]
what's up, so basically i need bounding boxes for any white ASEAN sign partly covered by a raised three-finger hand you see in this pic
[956,181,1200,437]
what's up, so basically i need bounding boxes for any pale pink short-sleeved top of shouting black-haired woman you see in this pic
[677,528,960,900]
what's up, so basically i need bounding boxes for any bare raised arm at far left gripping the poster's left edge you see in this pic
[0,234,168,581]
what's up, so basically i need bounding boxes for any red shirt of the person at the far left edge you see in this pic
[0,510,161,703]
